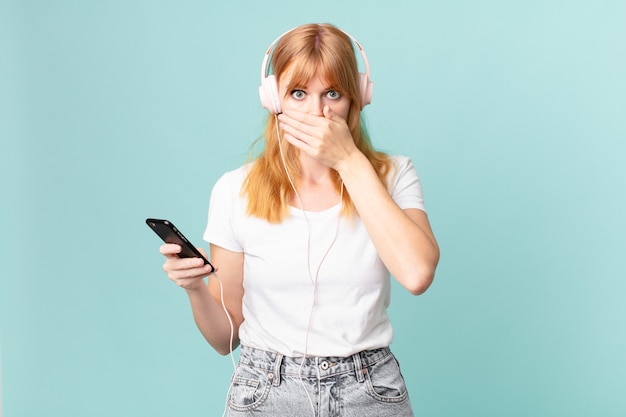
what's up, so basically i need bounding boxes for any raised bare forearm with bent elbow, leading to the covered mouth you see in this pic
[338,152,439,294]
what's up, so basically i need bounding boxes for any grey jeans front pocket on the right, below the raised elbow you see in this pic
[365,354,409,403]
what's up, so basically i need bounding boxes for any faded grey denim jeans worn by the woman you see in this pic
[228,346,413,417]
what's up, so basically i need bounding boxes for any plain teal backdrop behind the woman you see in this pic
[0,0,626,417]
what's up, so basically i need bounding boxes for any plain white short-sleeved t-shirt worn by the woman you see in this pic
[204,156,424,357]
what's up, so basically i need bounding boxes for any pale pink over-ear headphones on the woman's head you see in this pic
[259,29,374,114]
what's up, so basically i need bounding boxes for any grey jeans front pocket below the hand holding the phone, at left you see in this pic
[228,365,272,411]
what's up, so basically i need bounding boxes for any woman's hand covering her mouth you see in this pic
[278,106,357,170]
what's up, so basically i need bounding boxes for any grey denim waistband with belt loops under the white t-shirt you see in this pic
[239,346,391,382]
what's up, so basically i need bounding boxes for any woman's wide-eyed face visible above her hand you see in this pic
[278,71,351,120]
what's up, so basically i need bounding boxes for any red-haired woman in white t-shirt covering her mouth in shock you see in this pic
[161,24,439,417]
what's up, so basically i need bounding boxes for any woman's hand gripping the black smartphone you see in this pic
[159,243,211,291]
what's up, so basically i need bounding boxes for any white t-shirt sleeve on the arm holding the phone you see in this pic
[203,169,243,252]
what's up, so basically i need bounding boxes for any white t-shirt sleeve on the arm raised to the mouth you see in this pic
[390,156,426,212]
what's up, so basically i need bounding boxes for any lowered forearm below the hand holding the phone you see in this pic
[187,278,239,355]
